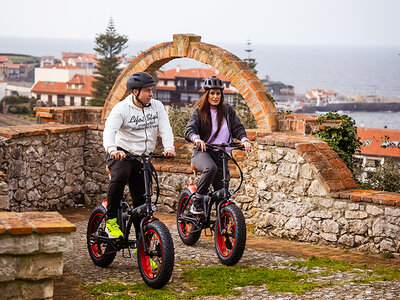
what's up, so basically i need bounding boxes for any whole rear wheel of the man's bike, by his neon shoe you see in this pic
[86,205,116,268]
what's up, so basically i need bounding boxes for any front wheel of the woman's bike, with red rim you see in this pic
[214,203,246,266]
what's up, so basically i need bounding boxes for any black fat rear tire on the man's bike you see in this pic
[86,205,117,268]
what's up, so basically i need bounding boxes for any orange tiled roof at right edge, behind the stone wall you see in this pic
[357,127,400,158]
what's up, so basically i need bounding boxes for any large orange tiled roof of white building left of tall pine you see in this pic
[32,75,94,96]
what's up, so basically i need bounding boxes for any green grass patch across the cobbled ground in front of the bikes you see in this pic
[89,257,400,300]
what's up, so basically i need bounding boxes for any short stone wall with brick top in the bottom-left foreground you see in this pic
[0,212,75,299]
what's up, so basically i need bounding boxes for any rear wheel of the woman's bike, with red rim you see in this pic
[176,189,201,246]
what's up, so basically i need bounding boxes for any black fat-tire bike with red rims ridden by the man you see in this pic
[87,153,174,289]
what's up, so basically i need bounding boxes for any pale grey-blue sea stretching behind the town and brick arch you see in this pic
[0,36,400,130]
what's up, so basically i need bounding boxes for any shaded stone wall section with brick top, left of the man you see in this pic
[0,125,108,211]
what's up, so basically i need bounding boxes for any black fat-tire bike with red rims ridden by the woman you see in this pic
[176,143,246,266]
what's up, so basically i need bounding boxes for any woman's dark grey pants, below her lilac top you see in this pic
[192,149,229,195]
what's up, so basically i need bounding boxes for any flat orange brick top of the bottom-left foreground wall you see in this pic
[0,211,76,235]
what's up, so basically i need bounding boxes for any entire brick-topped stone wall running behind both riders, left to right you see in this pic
[0,125,400,252]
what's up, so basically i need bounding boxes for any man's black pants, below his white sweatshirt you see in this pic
[107,155,146,234]
